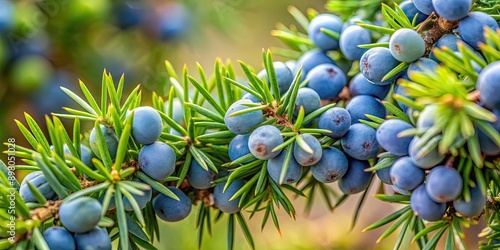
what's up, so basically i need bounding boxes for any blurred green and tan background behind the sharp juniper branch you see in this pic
[0,0,480,249]
